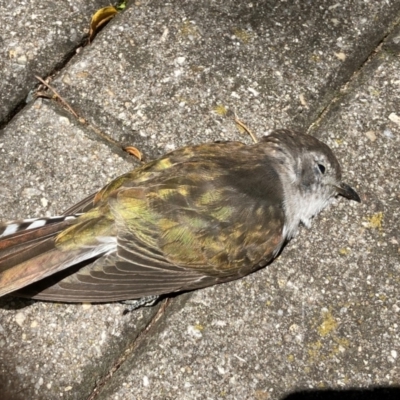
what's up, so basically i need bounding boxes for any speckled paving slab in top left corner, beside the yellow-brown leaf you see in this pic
[0,0,109,125]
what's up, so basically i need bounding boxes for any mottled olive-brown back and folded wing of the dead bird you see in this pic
[5,143,285,302]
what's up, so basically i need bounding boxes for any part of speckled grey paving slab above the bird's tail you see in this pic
[0,99,139,221]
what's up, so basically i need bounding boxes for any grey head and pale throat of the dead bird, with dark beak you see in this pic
[263,130,360,239]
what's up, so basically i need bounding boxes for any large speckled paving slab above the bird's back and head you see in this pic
[50,0,400,157]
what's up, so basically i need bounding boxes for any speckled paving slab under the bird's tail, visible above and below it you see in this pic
[0,100,156,399]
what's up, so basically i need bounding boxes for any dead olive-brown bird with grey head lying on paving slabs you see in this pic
[0,129,361,305]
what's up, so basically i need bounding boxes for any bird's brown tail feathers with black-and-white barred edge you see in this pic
[0,214,109,297]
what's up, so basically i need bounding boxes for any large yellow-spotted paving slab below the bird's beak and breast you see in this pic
[94,14,400,400]
